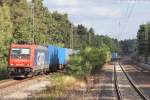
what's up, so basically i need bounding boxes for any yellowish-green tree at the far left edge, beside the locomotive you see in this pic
[0,3,12,62]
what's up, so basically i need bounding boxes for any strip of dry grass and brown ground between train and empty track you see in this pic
[30,64,115,100]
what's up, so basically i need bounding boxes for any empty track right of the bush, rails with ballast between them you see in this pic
[114,63,149,100]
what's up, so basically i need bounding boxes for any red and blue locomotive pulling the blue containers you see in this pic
[8,44,49,77]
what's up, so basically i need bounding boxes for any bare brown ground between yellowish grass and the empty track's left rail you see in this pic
[66,64,115,100]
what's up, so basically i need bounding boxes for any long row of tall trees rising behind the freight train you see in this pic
[0,0,120,63]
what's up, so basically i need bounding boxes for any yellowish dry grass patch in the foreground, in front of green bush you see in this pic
[32,73,77,100]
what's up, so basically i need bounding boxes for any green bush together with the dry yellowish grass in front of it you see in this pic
[32,45,110,100]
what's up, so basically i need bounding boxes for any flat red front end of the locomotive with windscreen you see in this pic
[8,44,34,76]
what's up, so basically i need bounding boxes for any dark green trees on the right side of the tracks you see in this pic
[120,22,150,57]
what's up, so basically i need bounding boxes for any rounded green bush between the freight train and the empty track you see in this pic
[68,45,110,78]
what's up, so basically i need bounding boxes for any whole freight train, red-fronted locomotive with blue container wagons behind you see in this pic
[8,44,75,77]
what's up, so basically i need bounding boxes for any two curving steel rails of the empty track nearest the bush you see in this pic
[114,63,149,100]
